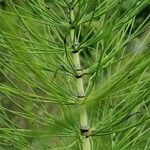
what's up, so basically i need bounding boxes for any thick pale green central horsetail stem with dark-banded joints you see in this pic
[70,6,91,150]
